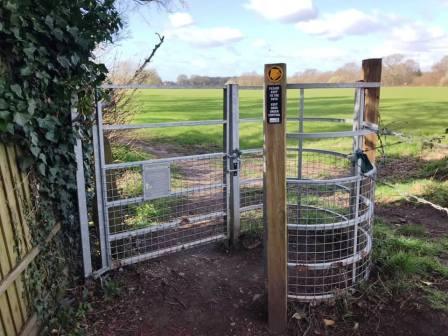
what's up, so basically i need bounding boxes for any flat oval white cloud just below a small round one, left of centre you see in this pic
[167,26,243,47]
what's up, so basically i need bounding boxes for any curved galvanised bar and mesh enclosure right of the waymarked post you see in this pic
[286,85,376,301]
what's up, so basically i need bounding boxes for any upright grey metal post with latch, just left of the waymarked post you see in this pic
[226,84,241,244]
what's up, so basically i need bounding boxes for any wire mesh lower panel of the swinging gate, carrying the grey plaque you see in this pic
[105,154,226,266]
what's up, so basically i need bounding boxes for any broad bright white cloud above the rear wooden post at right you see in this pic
[296,9,400,40]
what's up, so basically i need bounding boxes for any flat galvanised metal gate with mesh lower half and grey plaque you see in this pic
[86,84,263,274]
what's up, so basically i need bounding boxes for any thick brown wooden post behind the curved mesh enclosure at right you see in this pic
[362,58,382,163]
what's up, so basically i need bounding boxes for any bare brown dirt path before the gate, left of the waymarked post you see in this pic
[89,245,268,336]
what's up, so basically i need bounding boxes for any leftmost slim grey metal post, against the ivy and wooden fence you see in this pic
[71,95,92,278]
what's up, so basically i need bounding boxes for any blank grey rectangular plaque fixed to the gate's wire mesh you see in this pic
[143,163,171,200]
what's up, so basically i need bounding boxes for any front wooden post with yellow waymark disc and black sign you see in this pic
[264,63,287,333]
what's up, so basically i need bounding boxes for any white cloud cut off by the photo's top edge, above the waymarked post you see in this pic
[244,0,317,22]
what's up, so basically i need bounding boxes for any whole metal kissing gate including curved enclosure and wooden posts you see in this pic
[80,59,381,330]
